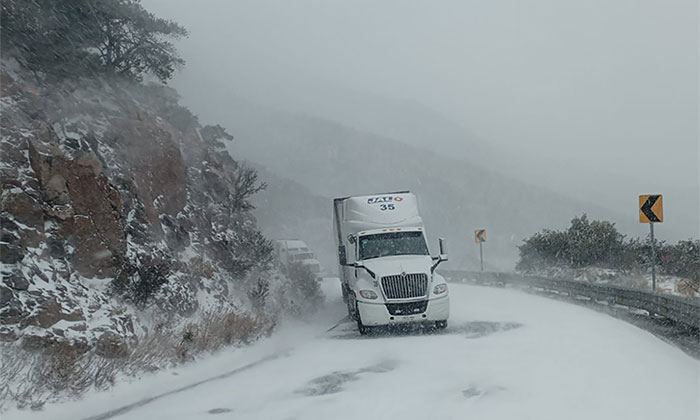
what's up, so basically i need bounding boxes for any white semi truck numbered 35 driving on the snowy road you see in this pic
[333,191,450,335]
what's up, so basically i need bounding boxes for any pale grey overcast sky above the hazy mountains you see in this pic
[143,0,700,238]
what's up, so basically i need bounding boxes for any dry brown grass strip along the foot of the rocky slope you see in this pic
[0,311,274,410]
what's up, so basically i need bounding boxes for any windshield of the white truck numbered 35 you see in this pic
[359,232,428,260]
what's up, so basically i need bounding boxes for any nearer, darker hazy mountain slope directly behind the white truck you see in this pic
[198,94,636,269]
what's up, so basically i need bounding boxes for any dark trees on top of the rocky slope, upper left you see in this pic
[0,0,187,82]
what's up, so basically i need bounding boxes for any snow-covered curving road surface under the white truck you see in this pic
[8,280,700,420]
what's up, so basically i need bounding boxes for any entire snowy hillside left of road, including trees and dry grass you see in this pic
[0,0,322,412]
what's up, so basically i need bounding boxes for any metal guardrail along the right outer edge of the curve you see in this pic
[439,270,700,328]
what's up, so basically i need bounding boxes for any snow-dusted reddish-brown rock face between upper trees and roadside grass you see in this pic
[0,60,304,388]
